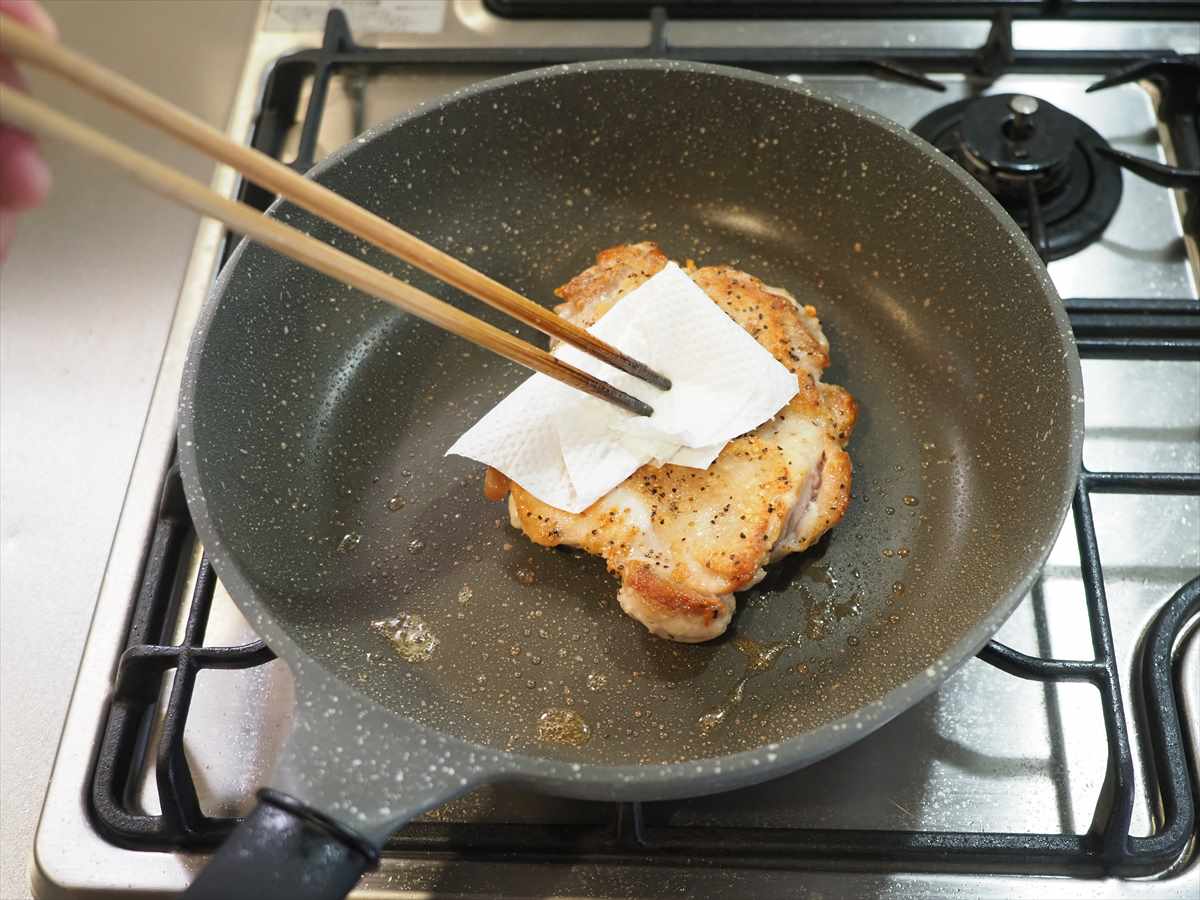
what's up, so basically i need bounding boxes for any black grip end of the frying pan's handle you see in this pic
[184,788,379,900]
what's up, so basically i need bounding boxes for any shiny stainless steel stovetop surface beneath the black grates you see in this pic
[28,0,1200,898]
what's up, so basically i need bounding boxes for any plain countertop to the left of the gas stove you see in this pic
[0,0,259,900]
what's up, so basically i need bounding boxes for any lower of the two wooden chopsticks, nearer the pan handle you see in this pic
[0,85,654,415]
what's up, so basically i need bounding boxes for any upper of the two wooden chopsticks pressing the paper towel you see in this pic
[0,18,671,390]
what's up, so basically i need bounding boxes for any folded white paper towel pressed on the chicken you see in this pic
[446,263,799,512]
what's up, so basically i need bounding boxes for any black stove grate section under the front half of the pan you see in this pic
[91,465,1200,876]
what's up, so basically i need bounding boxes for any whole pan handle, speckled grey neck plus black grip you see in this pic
[184,661,496,900]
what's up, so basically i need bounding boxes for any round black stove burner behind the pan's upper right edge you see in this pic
[912,94,1121,262]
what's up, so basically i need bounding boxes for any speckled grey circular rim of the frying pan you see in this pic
[178,59,1084,802]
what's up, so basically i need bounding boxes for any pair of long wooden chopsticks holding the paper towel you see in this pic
[0,16,671,415]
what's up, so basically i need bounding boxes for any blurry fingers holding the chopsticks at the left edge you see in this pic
[0,0,58,260]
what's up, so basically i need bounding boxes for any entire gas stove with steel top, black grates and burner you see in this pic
[35,0,1200,898]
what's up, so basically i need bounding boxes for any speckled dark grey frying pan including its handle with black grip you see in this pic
[179,61,1082,899]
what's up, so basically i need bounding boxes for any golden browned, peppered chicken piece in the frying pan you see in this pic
[487,242,857,642]
